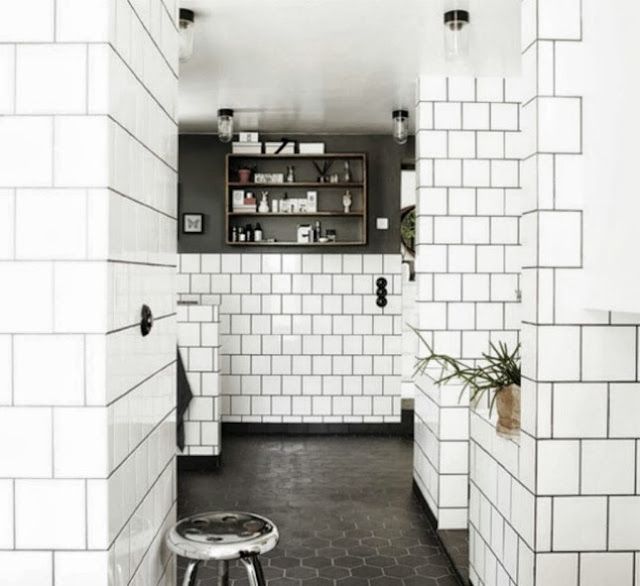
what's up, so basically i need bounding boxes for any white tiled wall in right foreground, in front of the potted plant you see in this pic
[472,0,640,586]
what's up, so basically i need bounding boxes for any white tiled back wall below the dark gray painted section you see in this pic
[178,253,402,423]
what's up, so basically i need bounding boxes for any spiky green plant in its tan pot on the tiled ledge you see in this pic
[413,328,521,436]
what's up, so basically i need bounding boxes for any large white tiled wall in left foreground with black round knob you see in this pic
[0,0,178,586]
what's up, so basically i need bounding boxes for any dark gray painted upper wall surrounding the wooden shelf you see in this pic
[178,134,415,254]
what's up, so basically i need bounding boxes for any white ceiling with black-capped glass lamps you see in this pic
[179,0,520,134]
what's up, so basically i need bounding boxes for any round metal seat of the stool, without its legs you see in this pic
[167,511,279,560]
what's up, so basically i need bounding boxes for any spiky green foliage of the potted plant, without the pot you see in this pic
[411,327,521,413]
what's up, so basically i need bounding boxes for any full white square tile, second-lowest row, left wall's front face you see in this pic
[15,480,86,549]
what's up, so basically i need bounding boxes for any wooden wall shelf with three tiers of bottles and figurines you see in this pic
[225,153,367,248]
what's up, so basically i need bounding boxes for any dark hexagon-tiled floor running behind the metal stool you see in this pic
[178,436,458,586]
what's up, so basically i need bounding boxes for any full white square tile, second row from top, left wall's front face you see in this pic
[16,45,87,114]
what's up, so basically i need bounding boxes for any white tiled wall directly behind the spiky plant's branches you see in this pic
[414,77,521,529]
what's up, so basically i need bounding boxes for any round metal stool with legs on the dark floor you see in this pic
[166,511,280,586]
